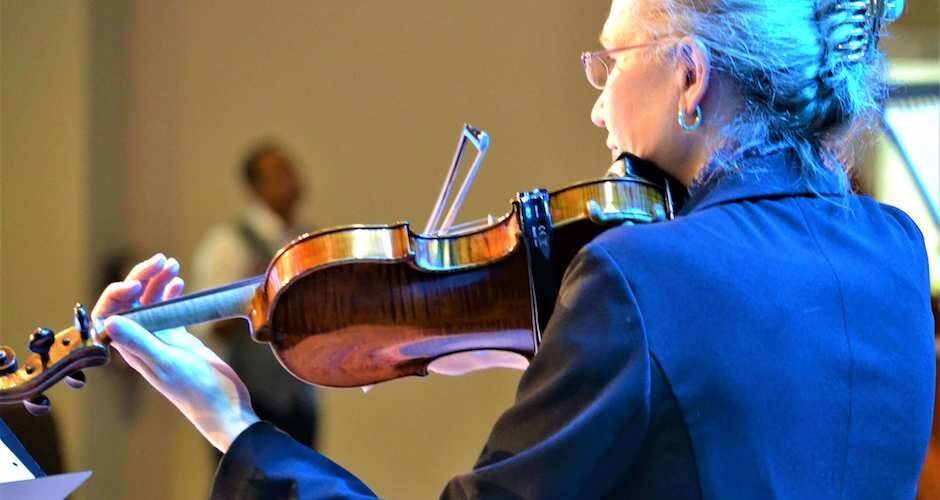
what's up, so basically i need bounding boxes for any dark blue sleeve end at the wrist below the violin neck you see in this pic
[211,422,378,500]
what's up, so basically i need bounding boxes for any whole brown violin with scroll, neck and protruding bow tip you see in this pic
[0,125,682,414]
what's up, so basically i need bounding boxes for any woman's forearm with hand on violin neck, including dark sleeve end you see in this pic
[92,254,375,499]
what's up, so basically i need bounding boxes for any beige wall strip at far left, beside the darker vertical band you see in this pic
[0,1,90,484]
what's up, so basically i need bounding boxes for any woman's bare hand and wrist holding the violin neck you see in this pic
[92,254,258,453]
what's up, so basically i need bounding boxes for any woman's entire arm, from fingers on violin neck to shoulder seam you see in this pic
[96,241,650,498]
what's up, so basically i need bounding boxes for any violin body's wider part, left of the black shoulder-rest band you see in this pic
[254,227,536,387]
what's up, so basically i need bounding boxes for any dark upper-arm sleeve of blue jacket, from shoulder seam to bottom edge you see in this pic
[441,244,650,499]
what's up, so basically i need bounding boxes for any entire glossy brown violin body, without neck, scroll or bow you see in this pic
[251,171,666,387]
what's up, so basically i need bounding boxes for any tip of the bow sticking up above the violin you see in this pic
[424,123,490,234]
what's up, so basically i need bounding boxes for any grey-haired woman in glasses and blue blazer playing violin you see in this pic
[93,0,935,499]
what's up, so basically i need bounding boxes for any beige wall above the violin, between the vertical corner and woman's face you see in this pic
[127,1,606,258]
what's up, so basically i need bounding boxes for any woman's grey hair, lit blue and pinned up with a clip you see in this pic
[643,0,903,188]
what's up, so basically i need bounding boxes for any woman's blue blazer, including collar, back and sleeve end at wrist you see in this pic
[213,152,935,500]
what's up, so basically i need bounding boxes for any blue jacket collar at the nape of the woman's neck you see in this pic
[679,149,848,215]
